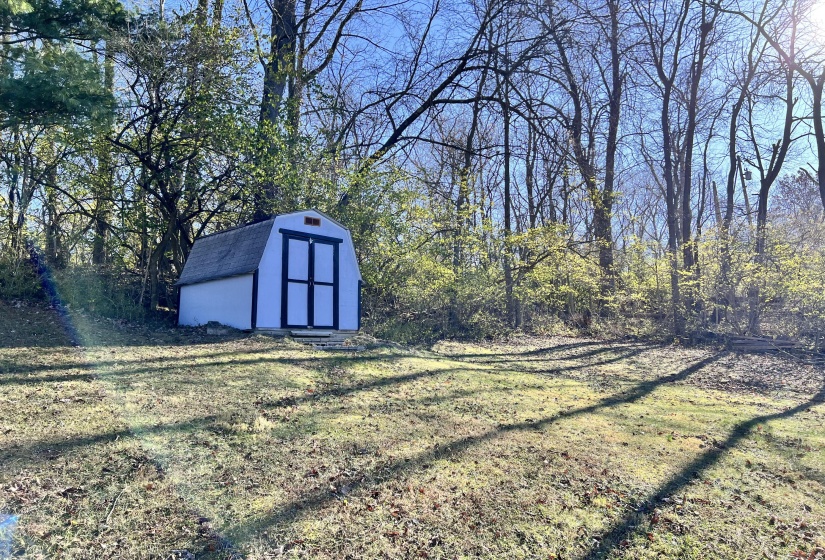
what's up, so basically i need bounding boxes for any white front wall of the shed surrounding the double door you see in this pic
[250,210,361,330]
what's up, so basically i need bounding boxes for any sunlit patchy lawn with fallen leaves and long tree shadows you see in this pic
[0,303,825,559]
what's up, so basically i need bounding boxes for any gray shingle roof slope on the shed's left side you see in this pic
[175,217,275,286]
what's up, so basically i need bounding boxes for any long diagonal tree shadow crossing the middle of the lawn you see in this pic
[217,352,725,539]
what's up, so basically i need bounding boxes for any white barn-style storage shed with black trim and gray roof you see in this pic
[176,210,361,334]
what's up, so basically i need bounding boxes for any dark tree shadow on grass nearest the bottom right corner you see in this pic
[585,386,825,558]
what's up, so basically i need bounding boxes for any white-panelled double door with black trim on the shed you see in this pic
[281,234,340,329]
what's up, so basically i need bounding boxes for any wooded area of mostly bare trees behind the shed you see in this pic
[0,0,825,342]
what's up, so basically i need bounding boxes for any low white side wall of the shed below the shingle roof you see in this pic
[178,274,252,329]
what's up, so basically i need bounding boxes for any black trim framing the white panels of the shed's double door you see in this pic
[279,229,344,330]
